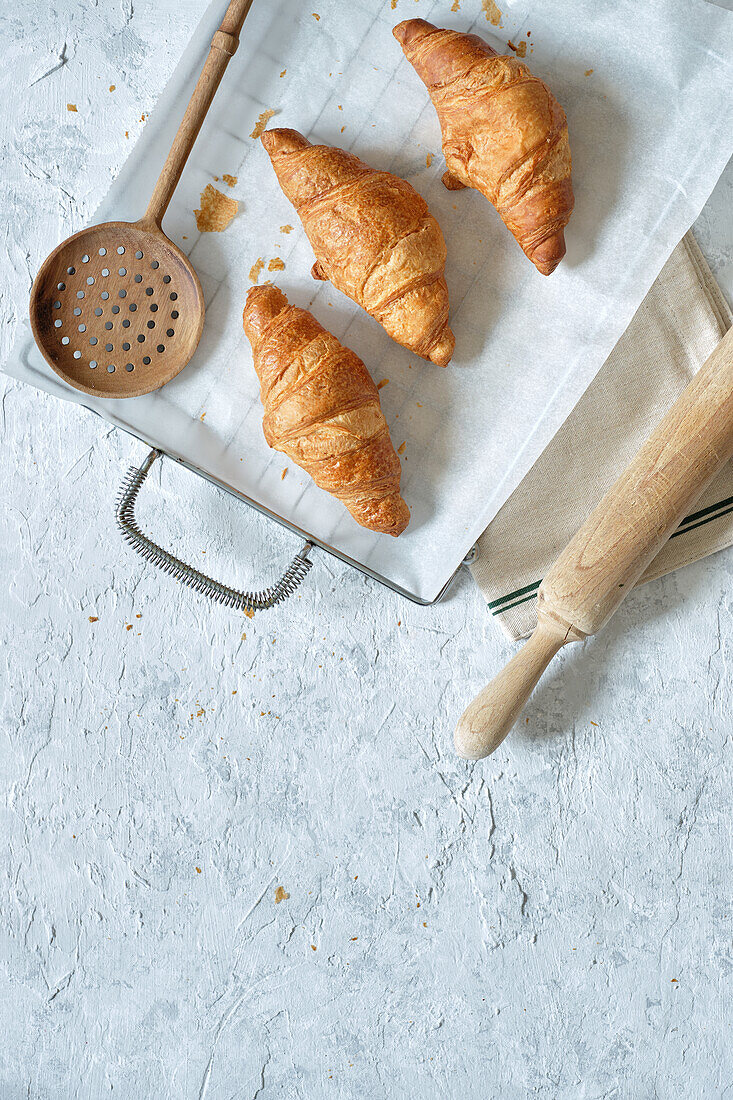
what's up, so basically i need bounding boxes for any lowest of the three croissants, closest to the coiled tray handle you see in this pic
[243,286,409,536]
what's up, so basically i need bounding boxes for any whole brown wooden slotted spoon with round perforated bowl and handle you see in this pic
[30,0,253,397]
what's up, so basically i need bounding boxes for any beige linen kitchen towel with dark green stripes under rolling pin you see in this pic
[471,233,733,640]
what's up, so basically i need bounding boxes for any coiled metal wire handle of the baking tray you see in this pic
[114,450,313,612]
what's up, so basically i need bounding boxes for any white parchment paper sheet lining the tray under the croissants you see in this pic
[6,0,733,600]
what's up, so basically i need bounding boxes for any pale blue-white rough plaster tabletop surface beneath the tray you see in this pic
[0,0,733,1100]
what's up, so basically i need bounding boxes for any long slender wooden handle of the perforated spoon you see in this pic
[142,0,253,229]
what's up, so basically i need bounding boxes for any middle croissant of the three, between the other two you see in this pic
[262,130,456,366]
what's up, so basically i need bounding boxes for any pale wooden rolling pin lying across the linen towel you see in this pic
[455,329,733,760]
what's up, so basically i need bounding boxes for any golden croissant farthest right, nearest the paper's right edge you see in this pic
[393,19,575,275]
